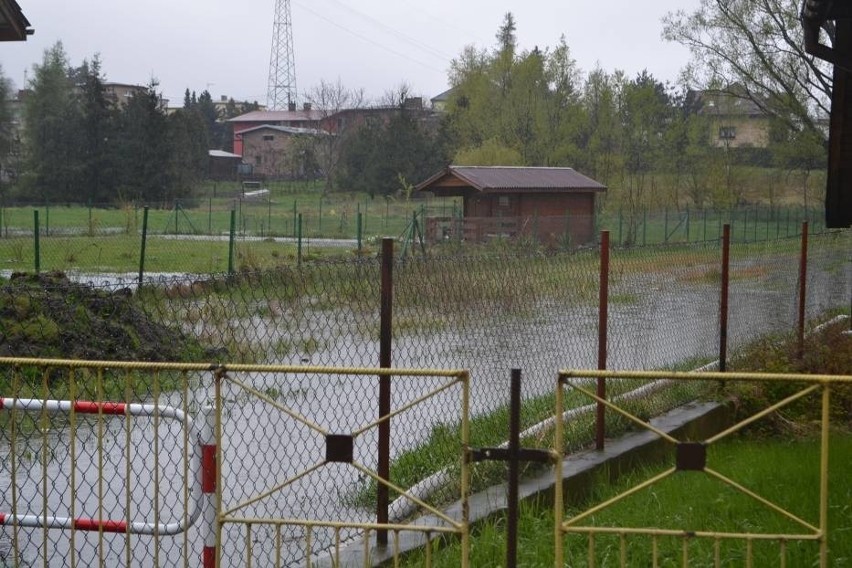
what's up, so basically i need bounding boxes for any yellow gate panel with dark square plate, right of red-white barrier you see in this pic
[209,365,469,566]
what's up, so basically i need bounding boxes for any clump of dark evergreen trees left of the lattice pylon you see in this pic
[0,42,257,206]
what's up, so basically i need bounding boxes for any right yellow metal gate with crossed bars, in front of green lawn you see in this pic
[554,371,852,567]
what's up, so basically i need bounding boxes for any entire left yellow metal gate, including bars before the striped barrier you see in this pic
[0,358,469,568]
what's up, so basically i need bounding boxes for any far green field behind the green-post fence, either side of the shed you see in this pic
[0,178,836,273]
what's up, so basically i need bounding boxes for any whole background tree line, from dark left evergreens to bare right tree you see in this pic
[0,0,830,214]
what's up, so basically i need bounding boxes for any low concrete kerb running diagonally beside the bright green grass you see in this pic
[312,402,733,568]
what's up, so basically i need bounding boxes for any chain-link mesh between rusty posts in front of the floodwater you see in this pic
[0,227,852,566]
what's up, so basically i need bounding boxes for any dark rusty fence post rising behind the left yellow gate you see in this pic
[376,238,393,545]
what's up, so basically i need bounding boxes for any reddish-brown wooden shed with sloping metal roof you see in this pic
[416,166,606,246]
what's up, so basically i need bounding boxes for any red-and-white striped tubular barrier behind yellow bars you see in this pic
[0,398,200,535]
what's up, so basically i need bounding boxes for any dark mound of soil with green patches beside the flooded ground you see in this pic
[0,272,202,361]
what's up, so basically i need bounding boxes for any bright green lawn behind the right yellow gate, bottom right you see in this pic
[404,434,852,567]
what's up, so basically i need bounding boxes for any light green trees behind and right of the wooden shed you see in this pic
[446,12,827,222]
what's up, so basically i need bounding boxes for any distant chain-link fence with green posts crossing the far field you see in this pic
[0,201,825,282]
